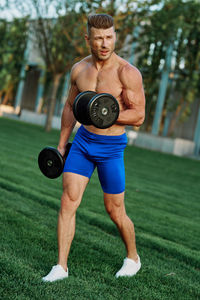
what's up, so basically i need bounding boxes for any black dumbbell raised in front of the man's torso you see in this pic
[73,91,119,129]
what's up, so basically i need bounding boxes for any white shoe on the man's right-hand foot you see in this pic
[115,256,141,278]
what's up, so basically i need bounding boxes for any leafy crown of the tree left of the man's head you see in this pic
[33,12,86,75]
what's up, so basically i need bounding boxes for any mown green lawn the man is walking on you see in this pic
[0,118,200,300]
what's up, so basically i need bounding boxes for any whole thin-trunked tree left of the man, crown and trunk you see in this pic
[27,0,87,131]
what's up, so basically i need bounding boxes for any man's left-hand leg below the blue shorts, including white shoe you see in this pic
[42,172,89,282]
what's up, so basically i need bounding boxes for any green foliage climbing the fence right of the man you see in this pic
[137,0,200,128]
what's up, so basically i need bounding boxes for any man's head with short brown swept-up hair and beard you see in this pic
[85,14,116,60]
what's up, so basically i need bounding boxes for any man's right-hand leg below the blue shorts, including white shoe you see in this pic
[104,192,141,277]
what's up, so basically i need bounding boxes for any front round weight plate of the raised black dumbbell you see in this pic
[87,93,119,129]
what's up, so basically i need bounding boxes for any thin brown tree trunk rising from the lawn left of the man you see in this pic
[45,74,62,131]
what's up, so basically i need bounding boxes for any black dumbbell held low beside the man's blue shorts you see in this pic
[38,143,72,179]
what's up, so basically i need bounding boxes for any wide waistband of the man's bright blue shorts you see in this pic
[78,125,127,143]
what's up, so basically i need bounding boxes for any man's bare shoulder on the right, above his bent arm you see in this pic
[119,58,142,86]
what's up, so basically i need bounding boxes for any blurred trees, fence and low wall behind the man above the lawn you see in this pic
[0,0,200,157]
